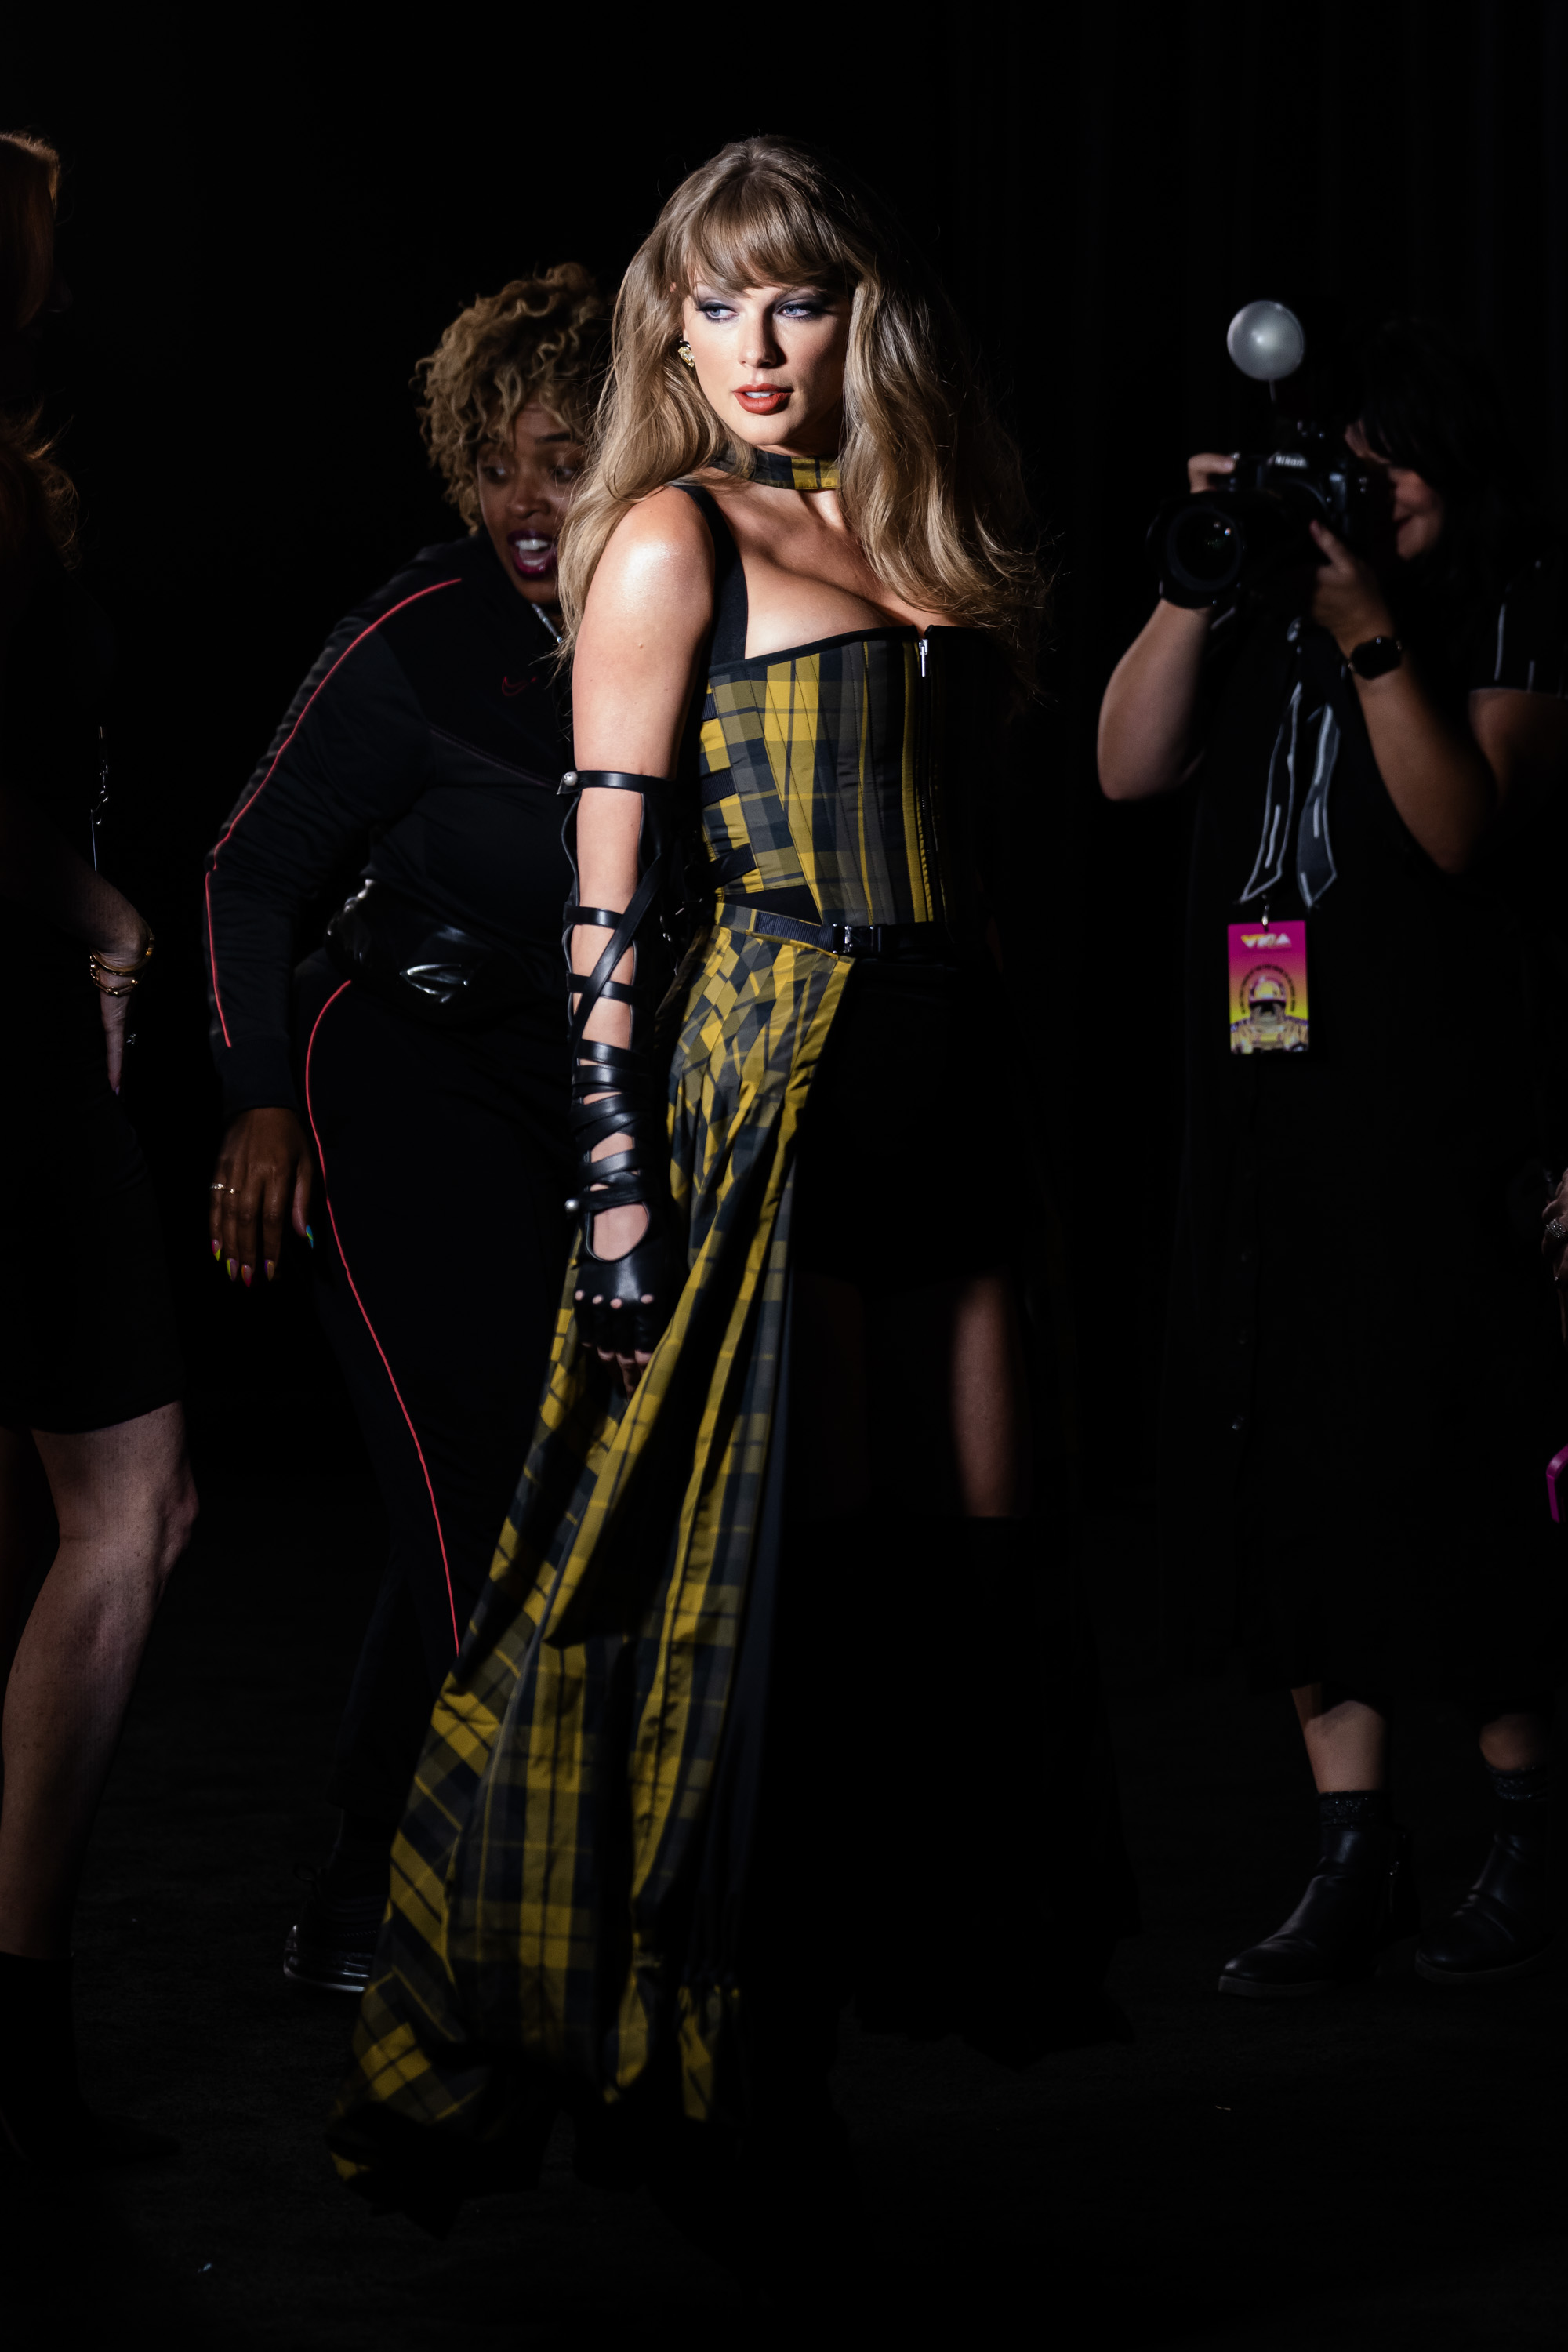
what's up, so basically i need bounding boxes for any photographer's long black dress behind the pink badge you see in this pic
[1161,557,1568,1719]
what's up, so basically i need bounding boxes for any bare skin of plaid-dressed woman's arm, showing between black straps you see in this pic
[572,489,713,1392]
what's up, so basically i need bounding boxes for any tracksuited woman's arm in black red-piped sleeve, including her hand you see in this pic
[205,614,439,1289]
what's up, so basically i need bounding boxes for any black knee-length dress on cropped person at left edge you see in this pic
[0,522,183,1432]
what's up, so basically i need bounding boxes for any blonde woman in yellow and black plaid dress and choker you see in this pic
[332,139,1131,2227]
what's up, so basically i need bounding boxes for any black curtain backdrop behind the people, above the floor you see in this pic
[0,0,1568,1501]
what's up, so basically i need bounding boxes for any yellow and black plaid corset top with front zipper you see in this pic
[699,628,961,924]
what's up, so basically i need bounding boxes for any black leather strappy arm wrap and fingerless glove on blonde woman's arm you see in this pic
[560,769,687,1355]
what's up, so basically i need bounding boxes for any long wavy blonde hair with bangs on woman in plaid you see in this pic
[560,139,1046,677]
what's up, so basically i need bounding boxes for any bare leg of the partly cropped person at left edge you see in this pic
[0,1404,195,1959]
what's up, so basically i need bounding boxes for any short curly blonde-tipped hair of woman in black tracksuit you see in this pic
[414,261,609,529]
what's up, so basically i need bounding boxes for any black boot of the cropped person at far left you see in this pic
[0,1952,179,2171]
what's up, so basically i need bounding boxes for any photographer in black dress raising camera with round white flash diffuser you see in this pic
[1100,303,1568,1997]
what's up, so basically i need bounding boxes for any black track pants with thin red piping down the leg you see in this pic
[294,955,569,1823]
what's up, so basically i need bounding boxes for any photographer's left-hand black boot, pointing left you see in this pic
[1220,1790,1420,1999]
